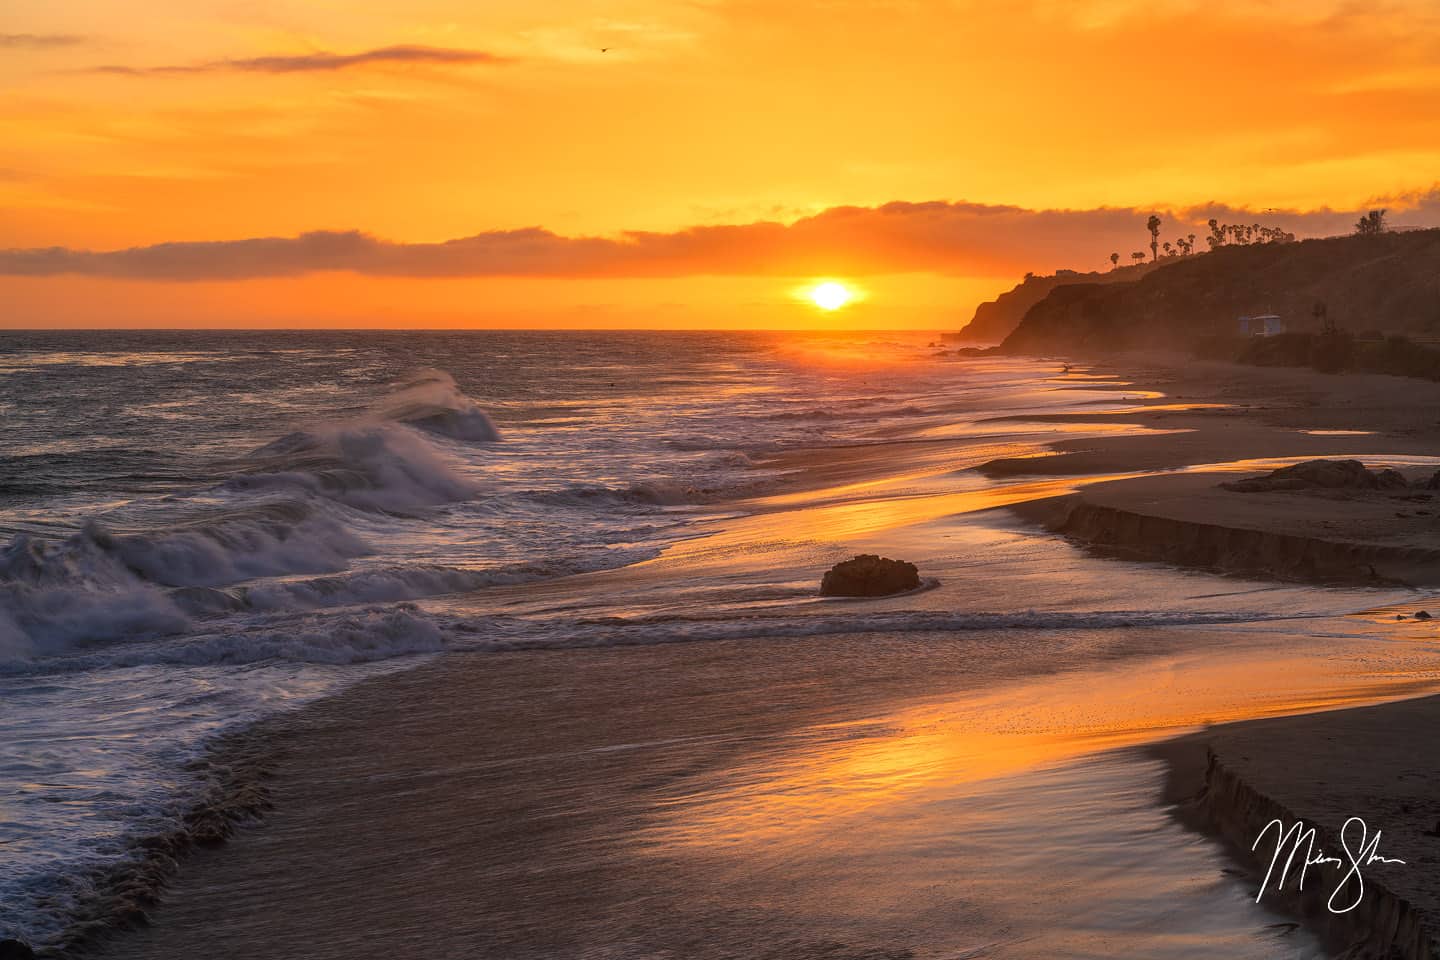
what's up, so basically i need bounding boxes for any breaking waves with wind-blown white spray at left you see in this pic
[0,370,504,671]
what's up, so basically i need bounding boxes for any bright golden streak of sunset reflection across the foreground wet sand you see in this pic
[657,613,1440,843]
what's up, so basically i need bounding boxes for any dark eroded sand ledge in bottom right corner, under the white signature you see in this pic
[1155,697,1440,960]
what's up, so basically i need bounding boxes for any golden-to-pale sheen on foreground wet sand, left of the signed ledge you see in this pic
[639,616,1440,959]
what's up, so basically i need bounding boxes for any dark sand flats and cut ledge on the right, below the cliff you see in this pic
[1002,358,1440,586]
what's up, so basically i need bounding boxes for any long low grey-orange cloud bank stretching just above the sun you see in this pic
[0,191,1440,281]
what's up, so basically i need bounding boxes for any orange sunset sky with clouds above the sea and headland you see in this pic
[0,0,1440,330]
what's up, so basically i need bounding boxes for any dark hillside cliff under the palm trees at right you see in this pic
[1002,230,1440,353]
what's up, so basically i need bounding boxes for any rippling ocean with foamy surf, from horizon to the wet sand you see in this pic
[0,331,1428,956]
